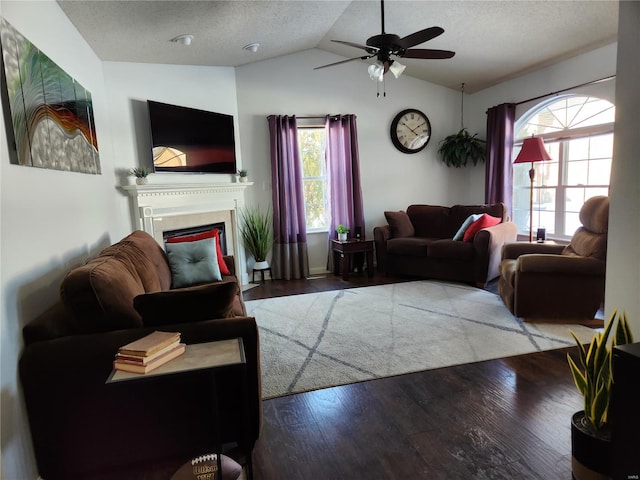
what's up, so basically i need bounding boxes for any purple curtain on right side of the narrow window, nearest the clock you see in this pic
[325,115,365,265]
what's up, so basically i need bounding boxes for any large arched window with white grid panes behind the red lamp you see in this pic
[513,95,615,239]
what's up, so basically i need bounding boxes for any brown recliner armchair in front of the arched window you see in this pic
[498,196,609,323]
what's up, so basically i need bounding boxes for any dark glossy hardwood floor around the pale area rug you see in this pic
[244,274,582,480]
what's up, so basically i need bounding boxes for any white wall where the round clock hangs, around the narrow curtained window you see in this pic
[236,50,464,272]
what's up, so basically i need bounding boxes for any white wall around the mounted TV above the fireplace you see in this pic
[103,62,242,237]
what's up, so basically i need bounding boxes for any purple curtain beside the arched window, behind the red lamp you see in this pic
[485,103,516,215]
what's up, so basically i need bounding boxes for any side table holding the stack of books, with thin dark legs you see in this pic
[106,338,253,480]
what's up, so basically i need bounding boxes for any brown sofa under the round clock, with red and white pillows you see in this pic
[373,203,518,287]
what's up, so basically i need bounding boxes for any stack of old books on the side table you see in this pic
[113,331,186,373]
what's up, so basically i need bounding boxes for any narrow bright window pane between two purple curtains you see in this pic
[298,125,329,232]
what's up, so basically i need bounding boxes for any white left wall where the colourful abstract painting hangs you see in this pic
[0,1,121,480]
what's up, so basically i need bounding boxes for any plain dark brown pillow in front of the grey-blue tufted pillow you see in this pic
[133,281,239,325]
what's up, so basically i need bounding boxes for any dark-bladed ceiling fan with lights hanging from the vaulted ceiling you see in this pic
[314,0,455,81]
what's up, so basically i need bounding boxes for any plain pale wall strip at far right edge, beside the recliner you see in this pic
[605,2,640,341]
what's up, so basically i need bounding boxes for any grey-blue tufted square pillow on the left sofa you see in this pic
[166,238,222,288]
